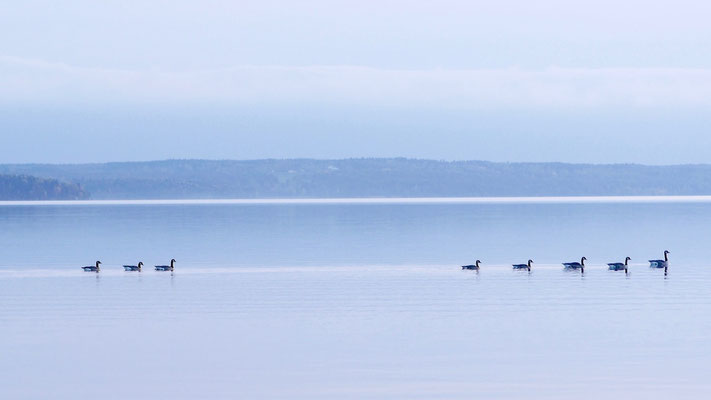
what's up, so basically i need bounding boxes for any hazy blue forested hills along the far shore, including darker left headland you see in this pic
[0,158,711,200]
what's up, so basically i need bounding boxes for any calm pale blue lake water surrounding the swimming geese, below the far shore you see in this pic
[0,201,711,399]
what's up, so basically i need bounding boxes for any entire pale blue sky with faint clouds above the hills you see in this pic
[0,0,711,164]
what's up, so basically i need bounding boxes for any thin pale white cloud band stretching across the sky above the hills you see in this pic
[0,57,711,109]
